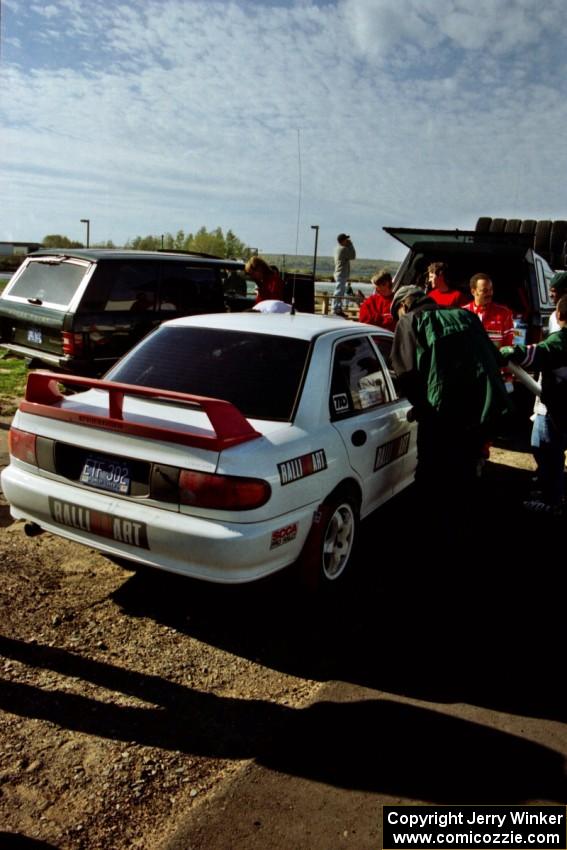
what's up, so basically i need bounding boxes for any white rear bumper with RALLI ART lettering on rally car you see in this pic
[2,463,317,584]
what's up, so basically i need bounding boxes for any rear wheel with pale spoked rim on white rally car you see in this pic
[296,489,360,594]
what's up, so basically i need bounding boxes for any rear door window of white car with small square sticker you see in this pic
[330,336,390,419]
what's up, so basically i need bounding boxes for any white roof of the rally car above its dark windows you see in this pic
[162,310,390,340]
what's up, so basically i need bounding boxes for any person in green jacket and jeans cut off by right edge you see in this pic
[500,295,567,517]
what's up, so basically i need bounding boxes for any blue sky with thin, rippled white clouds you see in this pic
[0,0,567,259]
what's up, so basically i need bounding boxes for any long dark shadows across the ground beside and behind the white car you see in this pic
[0,440,567,803]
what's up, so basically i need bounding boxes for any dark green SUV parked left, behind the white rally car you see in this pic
[0,249,246,375]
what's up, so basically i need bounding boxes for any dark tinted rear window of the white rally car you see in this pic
[106,327,309,422]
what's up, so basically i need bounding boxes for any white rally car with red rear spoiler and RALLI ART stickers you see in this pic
[2,312,416,585]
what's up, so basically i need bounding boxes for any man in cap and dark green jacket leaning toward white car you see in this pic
[392,286,510,496]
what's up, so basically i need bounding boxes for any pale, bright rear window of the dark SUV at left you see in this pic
[6,260,88,307]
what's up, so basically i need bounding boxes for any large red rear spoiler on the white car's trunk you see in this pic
[19,371,261,452]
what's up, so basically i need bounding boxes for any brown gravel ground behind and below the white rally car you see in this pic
[0,406,552,850]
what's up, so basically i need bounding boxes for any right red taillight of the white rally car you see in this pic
[179,469,272,511]
